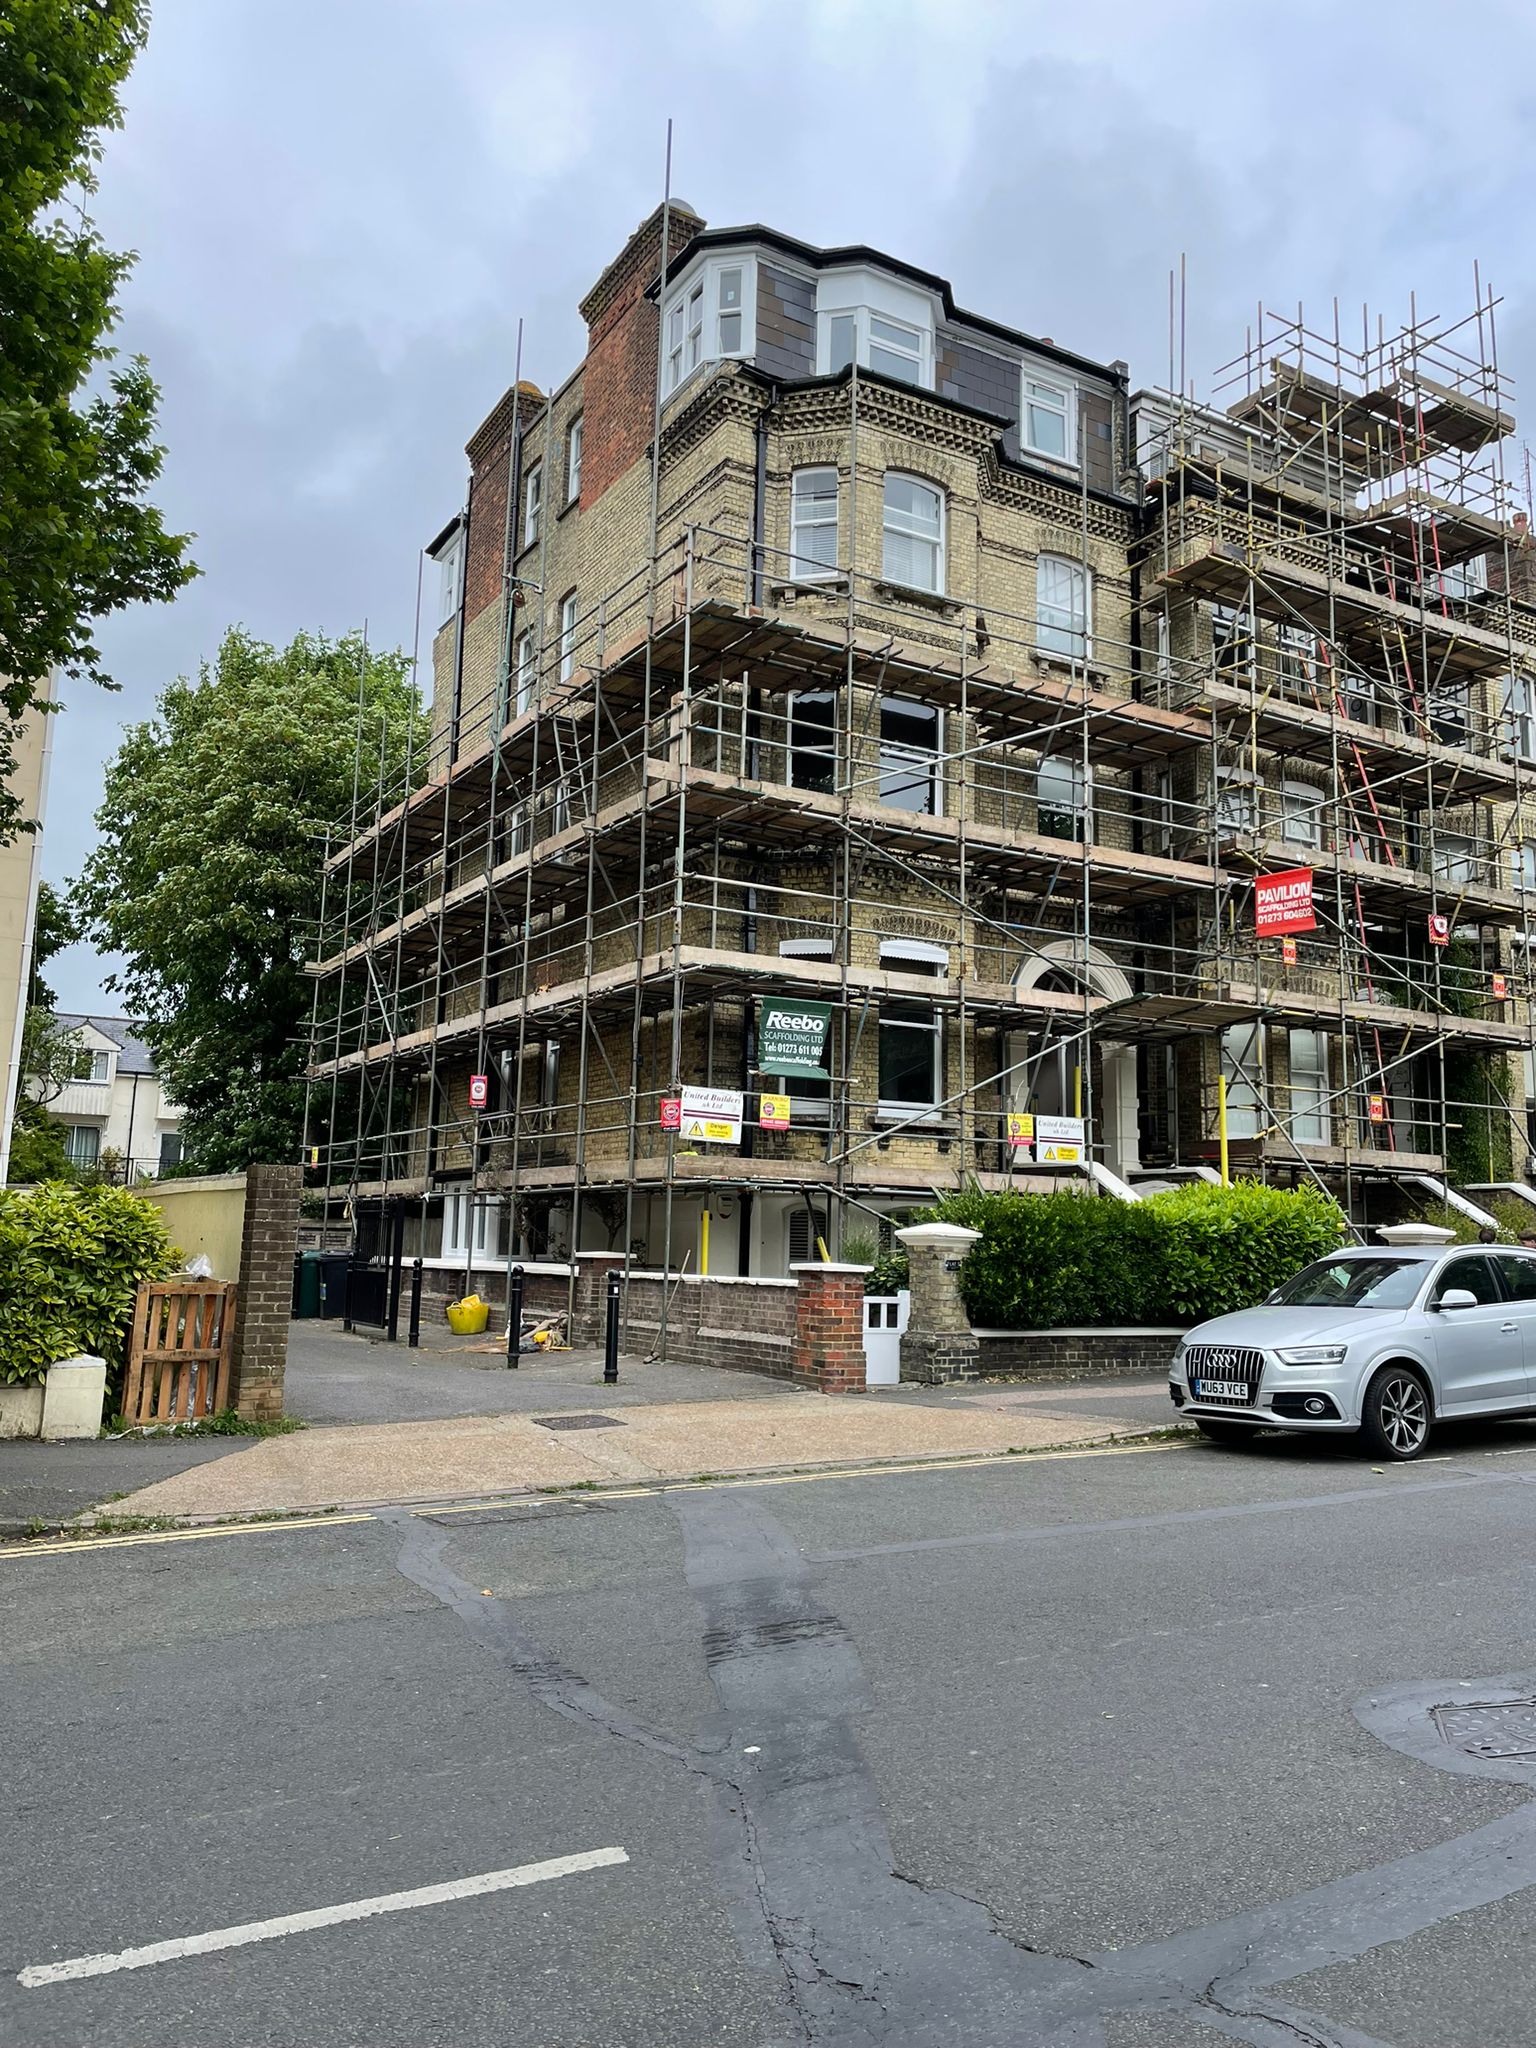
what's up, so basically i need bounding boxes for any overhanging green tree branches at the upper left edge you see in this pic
[0,0,197,840]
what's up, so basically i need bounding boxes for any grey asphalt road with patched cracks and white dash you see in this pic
[0,1427,1536,2048]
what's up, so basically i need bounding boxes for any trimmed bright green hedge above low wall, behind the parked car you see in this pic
[934,1182,1346,1329]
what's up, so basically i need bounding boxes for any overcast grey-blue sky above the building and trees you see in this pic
[45,0,1536,1010]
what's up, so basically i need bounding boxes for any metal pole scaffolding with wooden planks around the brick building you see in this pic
[307,272,1536,1302]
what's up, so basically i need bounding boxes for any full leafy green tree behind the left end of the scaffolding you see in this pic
[74,627,426,1174]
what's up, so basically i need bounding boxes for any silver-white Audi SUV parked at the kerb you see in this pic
[1169,1243,1536,1458]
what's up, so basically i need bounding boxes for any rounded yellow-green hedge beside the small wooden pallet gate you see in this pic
[0,1182,176,1382]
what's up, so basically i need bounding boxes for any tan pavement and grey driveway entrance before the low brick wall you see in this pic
[75,1323,1174,1518]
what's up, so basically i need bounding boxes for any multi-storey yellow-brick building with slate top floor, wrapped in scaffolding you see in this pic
[311,205,1536,1272]
